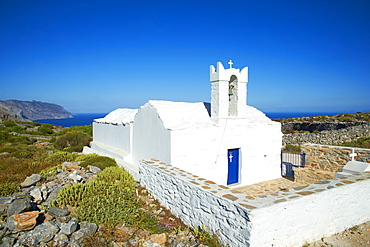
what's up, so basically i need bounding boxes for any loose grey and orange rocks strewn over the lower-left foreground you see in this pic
[0,162,211,247]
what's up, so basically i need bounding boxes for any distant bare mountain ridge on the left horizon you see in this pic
[0,100,73,121]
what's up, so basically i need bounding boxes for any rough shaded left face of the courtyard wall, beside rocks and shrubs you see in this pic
[139,161,251,246]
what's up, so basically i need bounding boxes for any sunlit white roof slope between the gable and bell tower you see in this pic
[147,100,213,130]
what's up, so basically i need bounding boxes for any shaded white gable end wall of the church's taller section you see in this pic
[132,103,171,165]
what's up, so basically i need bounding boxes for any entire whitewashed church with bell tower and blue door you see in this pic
[84,61,282,186]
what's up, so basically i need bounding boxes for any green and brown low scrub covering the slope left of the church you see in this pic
[0,119,221,247]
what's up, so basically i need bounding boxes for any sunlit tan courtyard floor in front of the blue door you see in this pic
[232,177,309,197]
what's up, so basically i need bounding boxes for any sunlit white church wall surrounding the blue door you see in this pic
[170,119,282,186]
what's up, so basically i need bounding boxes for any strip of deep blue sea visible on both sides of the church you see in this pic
[34,112,341,127]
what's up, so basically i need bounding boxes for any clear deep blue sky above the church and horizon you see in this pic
[0,0,370,113]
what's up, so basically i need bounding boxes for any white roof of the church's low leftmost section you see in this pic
[94,108,137,124]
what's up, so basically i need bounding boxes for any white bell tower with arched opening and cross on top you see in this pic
[210,60,248,122]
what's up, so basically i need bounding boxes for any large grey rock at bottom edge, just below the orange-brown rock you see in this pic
[22,221,59,246]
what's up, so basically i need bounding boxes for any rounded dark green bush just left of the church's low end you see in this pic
[54,132,91,152]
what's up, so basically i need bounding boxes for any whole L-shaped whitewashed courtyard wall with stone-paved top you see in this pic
[139,160,370,247]
